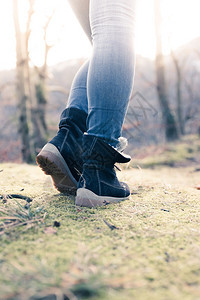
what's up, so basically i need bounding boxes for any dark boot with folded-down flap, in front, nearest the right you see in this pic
[76,134,131,207]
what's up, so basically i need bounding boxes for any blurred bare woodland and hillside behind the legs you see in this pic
[0,0,200,163]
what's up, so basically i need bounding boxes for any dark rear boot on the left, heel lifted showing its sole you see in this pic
[36,107,87,194]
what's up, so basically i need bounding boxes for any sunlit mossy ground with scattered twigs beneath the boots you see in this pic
[0,137,200,300]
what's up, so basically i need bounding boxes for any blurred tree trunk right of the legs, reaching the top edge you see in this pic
[154,0,179,141]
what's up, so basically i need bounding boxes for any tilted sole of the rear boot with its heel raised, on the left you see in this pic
[36,143,77,195]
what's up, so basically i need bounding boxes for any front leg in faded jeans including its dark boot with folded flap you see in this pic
[76,0,135,207]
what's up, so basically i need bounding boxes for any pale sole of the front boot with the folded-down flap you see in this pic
[75,188,129,208]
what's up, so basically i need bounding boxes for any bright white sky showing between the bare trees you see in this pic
[0,0,200,69]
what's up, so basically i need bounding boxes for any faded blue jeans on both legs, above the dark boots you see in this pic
[67,0,135,147]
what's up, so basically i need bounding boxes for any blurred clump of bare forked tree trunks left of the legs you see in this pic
[13,0,55,162]
